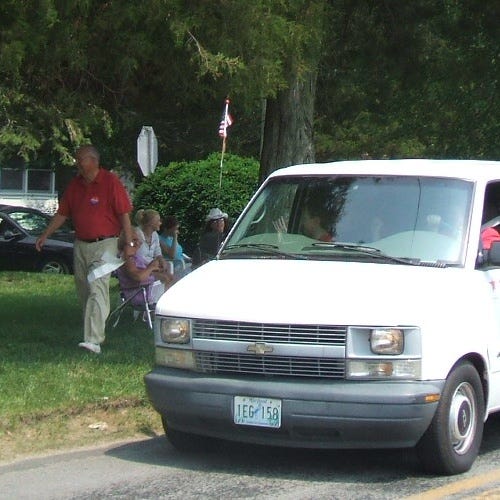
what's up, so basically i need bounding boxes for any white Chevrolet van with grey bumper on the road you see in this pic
[145,160,500,474]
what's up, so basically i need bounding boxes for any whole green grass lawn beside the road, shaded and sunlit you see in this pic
[0,272,160,458]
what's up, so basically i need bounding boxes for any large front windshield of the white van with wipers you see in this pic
[220,175,473,265]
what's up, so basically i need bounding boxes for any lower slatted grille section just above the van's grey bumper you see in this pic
[195,351,345,379]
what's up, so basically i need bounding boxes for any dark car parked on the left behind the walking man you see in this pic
[0,205,75,274]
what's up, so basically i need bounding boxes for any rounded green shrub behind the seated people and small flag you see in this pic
[133,153,259,253]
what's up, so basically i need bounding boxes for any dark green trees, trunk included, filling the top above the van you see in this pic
[0,0,500,180]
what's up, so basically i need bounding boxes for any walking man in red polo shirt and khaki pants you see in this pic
[36,145,133,354]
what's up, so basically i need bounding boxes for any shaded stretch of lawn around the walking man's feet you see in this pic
[0,272,153,363]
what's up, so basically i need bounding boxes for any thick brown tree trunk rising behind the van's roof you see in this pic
[259,74,316,182]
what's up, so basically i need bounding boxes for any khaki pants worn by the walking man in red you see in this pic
[74,238,118,344]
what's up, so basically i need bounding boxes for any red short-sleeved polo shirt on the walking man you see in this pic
[57,168,132,240]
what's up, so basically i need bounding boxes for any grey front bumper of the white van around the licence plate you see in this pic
[145,367,444,449]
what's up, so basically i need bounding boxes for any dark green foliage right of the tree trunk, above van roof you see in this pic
[315,0,500,160]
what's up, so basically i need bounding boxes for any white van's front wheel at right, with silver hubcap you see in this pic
[417,362,484,475]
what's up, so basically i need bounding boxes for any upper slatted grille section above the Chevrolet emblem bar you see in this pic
[192,319,347,346]
